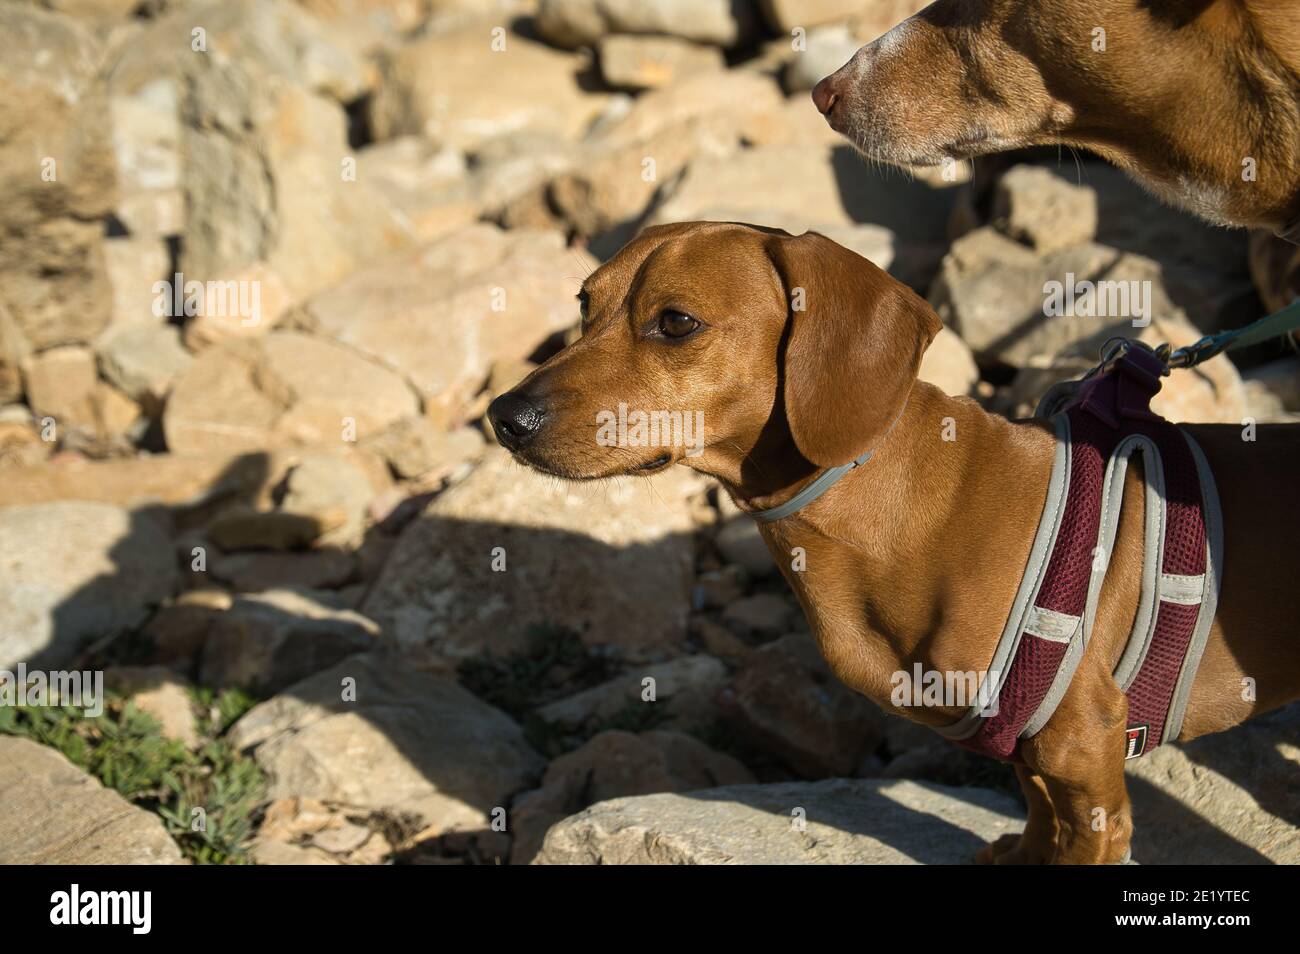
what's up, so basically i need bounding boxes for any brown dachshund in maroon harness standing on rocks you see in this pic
[489,222,1300,863]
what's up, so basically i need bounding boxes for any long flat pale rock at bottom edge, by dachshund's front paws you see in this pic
[534,779,1023,864]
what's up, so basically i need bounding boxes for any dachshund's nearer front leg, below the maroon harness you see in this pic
[1021,659,1132,864]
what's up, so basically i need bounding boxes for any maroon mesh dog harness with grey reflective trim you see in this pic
[940,344,1222,760]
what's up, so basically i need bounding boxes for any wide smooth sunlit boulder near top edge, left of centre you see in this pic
[371,23,607,149]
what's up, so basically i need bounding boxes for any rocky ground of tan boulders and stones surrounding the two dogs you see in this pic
[0,0,1300,864]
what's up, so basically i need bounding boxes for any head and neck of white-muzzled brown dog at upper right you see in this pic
[813,0,1300,237]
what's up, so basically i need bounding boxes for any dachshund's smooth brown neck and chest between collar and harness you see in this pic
[702,383,1054,724]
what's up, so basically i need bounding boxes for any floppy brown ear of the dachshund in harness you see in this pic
[768,231,941,467]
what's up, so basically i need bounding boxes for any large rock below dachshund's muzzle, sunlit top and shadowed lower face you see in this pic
[364,450,694,656]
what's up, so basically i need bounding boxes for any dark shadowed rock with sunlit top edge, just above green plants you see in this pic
[199,590,380,694]
